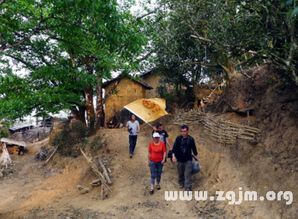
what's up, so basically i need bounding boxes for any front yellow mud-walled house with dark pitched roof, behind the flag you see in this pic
[103,75,152,124]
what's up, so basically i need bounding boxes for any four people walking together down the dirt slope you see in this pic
[127,115,198,194]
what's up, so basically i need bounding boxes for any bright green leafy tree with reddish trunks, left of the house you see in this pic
[0,0,147,130]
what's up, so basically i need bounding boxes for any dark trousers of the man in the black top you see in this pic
[177,160,192,191]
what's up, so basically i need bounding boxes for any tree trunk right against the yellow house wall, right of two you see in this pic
[95,77,105,129]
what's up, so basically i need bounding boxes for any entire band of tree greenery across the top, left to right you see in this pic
[0,0,298,121]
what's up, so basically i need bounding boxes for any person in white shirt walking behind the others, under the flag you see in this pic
[126,114,140,158]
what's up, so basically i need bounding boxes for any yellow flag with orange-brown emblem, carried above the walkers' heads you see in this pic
[124,98,168,123]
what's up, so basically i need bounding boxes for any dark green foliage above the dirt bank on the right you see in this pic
[154,0,298,90]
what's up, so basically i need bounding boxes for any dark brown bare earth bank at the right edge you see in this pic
[217,65,298,169]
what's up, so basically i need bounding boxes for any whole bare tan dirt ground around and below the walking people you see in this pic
[0,127,288,219]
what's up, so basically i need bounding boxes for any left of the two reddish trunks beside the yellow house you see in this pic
[85,88,95,134]
